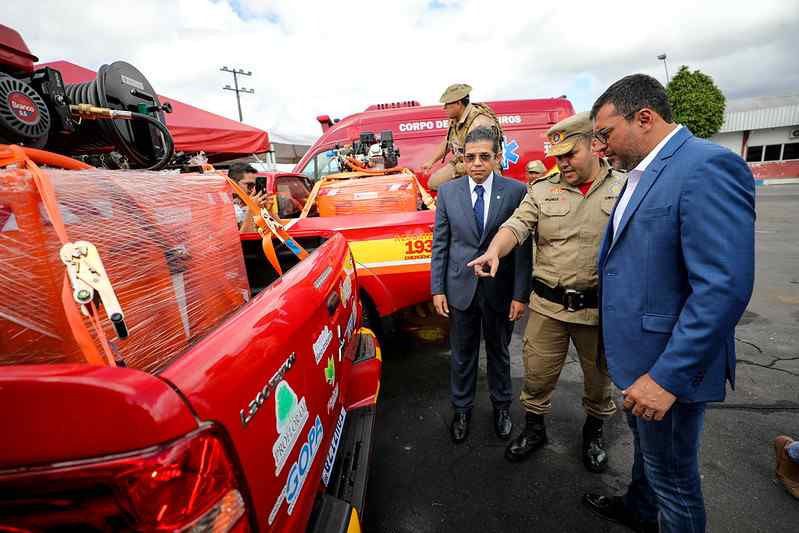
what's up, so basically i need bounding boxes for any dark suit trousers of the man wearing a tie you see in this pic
[449,283,513,412]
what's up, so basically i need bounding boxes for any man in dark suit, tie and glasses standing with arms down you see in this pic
[431,124,532,442]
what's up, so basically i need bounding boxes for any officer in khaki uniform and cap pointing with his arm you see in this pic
[469,113,624,472]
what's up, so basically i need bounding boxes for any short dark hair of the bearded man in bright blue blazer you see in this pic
[591,74,672,122]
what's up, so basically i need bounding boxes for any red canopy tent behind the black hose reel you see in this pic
[36,61,270,161]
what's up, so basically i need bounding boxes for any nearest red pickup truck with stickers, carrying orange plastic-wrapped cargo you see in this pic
[0,158,381,532]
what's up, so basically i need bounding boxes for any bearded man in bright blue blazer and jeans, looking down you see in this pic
[584,74,755,532]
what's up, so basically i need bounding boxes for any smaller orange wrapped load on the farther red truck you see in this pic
[316,173,419,217]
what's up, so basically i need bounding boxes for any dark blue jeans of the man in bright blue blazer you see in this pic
[624,402,706,533]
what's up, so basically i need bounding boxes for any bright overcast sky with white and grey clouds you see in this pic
[7,0,799,138]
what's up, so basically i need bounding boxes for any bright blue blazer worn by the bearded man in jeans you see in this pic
[599,128,755,402]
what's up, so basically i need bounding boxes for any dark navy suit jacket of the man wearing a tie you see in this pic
[430,172,533,313]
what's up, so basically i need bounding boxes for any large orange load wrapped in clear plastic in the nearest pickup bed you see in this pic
[0,168,249,372]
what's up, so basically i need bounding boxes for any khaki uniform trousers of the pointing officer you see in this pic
[520,309,616,418]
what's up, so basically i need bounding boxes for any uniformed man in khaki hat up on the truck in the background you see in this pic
[422,83,502,190]
